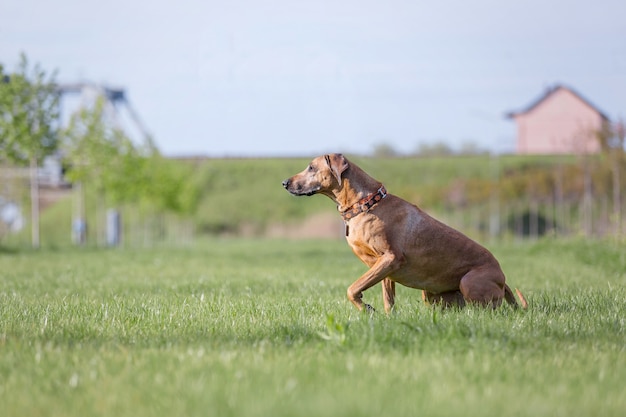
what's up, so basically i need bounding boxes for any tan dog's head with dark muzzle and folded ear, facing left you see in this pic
[283,153,349,195]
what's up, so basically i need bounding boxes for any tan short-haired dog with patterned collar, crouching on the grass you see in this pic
[283,154,528,312]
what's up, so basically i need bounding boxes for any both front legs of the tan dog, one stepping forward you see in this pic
[348,253,403,311]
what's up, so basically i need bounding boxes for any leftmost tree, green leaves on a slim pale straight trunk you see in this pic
[0,54,59,247]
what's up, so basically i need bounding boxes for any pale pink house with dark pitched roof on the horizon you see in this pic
[507,84,610,154]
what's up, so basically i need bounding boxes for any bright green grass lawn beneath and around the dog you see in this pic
[0,239,626,417]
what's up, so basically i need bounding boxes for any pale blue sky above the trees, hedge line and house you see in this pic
[0,0,626,156]
